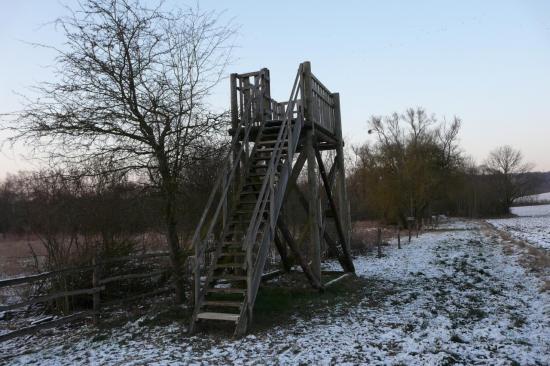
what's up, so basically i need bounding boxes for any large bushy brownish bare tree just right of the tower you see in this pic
[350,108,462,225]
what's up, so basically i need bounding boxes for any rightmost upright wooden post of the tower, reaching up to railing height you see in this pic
[332,93,351,253]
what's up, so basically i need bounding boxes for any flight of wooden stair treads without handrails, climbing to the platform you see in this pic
[194,120,298,332]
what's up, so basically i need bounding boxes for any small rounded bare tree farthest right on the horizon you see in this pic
[484,145,532,214]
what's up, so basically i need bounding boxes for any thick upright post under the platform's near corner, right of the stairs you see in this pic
[306,129,321,279]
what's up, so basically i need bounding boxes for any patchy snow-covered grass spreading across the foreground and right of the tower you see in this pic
[0,222,550,365]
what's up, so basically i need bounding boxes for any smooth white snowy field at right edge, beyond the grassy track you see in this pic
[487,205,550,250]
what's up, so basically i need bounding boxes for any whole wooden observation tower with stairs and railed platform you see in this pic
[190,62,354,335]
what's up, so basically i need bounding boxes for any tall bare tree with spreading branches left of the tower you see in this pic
[4,0,234,301]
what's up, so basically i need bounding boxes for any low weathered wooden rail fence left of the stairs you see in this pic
[0,252,177,342]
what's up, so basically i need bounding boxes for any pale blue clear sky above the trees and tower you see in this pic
[0,0,550,177]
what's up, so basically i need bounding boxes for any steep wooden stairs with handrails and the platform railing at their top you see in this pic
[190,69,303,335]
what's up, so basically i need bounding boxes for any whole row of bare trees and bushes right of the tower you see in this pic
[348,108,537,226]
